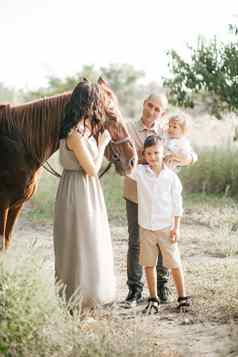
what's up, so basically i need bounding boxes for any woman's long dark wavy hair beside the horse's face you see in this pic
[60,80,105,139]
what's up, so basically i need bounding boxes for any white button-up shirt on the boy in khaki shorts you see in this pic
[128,165,183,231]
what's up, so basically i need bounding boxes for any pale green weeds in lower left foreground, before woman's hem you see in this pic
[0,246,160,357]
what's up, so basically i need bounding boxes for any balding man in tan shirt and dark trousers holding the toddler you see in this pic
[124,93,169,305]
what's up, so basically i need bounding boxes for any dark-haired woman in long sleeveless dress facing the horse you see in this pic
[54,81,115,308]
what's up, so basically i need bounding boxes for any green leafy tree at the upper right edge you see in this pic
[163,25,238,118]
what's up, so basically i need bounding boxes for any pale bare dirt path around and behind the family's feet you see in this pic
[12,211,238,357]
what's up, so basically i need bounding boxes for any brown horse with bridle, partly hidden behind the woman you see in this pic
[0,83,136,250]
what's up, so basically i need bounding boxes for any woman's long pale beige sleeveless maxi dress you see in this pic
[54,137,115,307]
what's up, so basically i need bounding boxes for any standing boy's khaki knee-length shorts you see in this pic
[139,227,181,269]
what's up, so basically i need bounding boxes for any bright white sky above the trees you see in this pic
[0,0,238,89]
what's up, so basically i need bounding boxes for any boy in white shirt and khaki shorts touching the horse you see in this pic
[127,135,191,314]
